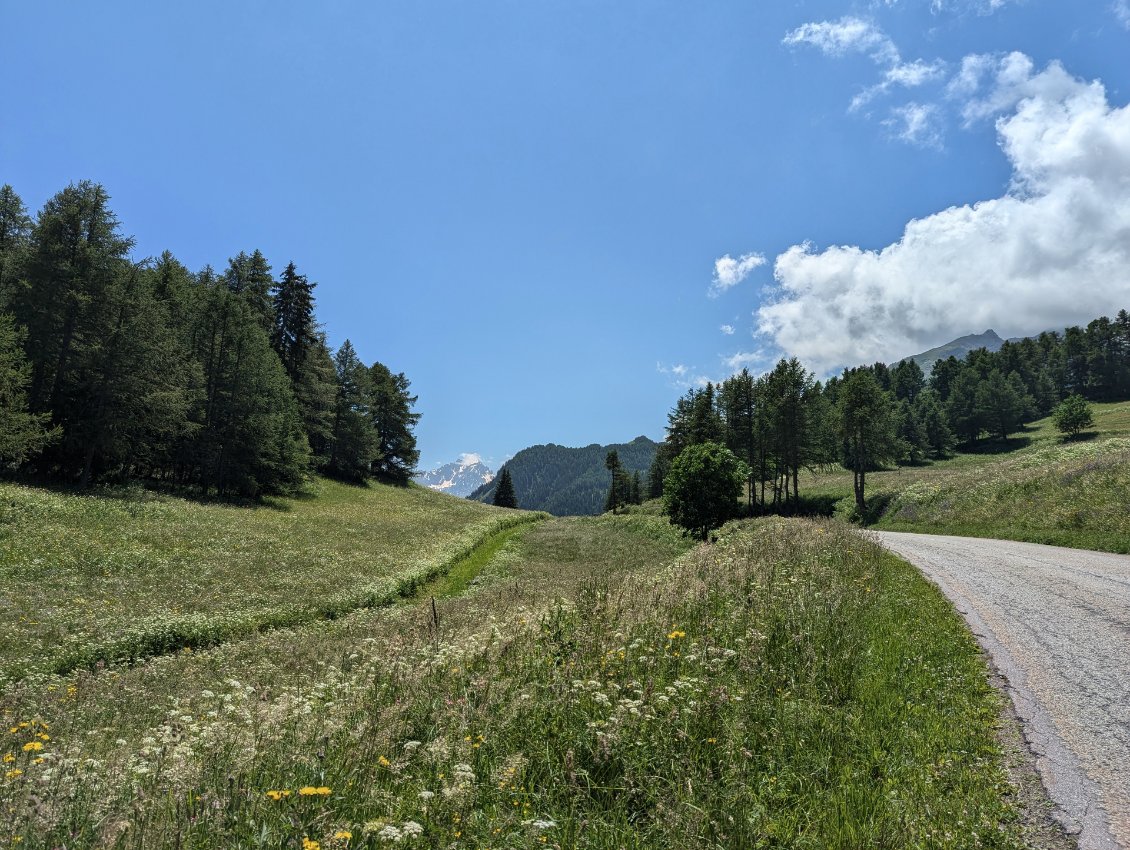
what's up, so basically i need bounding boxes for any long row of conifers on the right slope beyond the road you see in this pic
[647,310,1130,530]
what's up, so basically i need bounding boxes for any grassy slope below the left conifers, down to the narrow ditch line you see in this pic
[0,479,544,682]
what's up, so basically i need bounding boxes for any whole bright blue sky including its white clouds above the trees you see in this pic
[0,0,1130,467]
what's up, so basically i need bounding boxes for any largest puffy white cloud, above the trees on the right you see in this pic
[756,54,1130,373]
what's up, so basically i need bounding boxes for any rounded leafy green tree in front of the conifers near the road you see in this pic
[663,443,748,540]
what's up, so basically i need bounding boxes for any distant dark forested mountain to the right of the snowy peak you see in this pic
[469,436,659,517]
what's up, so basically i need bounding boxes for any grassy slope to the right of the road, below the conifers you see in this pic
[801,402,1130,552]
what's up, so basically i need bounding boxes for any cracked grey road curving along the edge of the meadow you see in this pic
[875,531,1130,850]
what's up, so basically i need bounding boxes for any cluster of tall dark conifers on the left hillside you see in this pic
[0,181,419,497]
